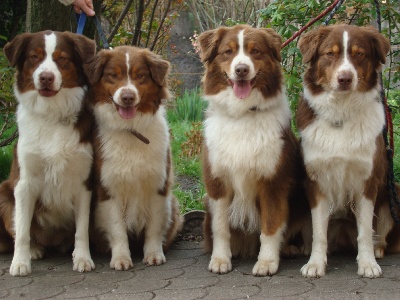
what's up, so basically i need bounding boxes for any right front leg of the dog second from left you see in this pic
[143,195,171,266]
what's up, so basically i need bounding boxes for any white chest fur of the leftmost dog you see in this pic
[17,88,93,225]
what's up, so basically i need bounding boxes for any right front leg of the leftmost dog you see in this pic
[72,188,95,272]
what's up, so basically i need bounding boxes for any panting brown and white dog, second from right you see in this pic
[199,25,307,276]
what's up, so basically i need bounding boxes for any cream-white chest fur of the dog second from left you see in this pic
[95,105,169,206]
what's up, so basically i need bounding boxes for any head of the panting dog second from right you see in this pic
[199,25,282,99]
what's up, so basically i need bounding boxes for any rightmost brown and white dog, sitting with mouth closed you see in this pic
[296,24,400,278]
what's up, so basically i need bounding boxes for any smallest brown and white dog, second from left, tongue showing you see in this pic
[88,46,182,270]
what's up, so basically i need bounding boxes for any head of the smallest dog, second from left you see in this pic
[87,46,169,119]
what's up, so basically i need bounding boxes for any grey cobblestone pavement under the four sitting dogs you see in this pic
[0,241,400,300]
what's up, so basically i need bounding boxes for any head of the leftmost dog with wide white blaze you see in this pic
[4,31,96,98]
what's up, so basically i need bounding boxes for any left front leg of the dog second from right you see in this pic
[208,198,232,274]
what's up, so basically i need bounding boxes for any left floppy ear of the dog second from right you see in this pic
[198,27,225,62]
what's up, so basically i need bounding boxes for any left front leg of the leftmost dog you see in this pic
[10,178,40,276]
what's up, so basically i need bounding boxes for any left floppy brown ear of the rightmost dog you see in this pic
[298,26,330,64]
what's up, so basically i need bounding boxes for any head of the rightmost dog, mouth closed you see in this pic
[299,24,390,94]
